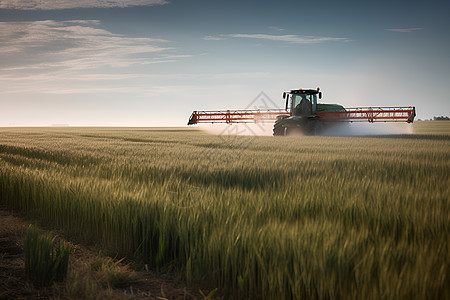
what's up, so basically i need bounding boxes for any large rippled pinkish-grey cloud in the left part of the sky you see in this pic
[0,20,175,71]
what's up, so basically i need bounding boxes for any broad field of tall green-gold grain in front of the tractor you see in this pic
[0,128,450,299]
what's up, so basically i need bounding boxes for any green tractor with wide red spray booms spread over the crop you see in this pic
[188,88,416,136]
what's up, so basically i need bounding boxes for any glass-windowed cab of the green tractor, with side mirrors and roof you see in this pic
[283,88,322,117]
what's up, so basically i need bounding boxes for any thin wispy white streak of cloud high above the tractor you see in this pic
[227,34,350,44]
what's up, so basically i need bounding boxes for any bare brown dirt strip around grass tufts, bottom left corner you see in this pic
[0,209,204,300]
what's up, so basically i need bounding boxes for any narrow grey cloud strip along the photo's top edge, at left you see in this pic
[0,0,169,10]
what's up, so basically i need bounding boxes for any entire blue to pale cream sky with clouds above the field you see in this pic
[0,0,450,126]
